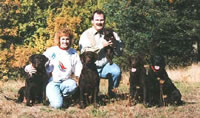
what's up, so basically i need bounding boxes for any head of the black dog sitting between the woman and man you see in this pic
[80,51,97,65]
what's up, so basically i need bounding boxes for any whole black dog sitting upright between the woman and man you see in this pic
[79,51,100,108]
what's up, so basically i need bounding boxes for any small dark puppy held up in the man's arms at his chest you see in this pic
[104,28,117,64]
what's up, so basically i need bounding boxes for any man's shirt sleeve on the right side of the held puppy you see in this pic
[113,32,124,56]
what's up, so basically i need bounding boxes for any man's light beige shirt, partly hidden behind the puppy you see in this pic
[79,27,122,67]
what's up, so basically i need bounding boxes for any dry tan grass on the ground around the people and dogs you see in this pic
[0,64,200,118]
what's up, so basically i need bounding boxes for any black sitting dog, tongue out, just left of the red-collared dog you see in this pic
[129,56,147,105]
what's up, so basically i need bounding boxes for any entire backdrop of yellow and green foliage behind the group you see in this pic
[0,0,200,78]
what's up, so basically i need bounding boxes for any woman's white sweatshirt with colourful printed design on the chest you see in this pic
[43,46,82,82]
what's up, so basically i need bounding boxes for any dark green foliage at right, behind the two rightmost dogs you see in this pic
[104,0,200,67]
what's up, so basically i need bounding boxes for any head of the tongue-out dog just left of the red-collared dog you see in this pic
[129,56,144,72]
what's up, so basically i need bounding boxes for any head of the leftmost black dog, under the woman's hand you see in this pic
[29,54,48,71]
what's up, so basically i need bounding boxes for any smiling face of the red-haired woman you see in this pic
[60,36,71,49]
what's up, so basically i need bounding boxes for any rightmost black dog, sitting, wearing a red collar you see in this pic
[148,55,182,106]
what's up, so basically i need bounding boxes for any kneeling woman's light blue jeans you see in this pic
[46,79,77,108]
